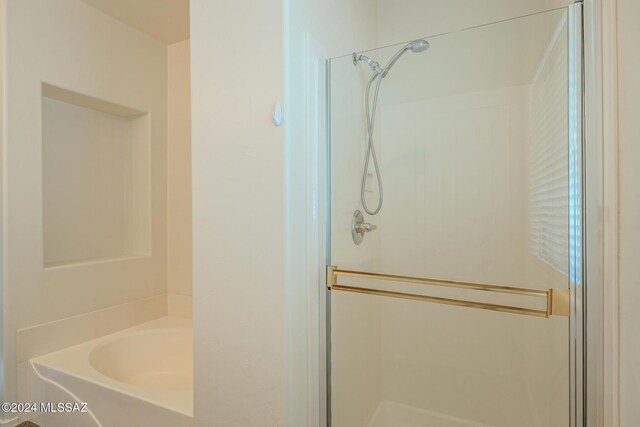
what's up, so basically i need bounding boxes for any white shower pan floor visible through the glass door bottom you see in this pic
[368,400,492,427]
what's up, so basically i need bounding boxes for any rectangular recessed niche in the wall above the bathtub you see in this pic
[42,84,151,267]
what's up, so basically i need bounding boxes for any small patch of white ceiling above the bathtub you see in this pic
[82,0,189,44]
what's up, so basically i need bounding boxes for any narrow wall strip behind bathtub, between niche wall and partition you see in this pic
[167,40,191,296]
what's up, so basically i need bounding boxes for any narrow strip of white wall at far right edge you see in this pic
[618,0,640,427]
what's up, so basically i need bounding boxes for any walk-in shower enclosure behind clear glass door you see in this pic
[326,4,586,427]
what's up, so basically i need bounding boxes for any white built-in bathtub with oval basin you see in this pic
[28,317,193,427]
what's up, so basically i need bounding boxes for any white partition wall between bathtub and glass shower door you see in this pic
[192,0,375,426]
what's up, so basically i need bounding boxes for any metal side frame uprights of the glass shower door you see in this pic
[318,0,613,427]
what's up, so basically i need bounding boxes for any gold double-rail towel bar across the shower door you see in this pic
[327,267,570,317]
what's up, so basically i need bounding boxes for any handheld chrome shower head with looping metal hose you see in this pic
[353,39,429,215]
